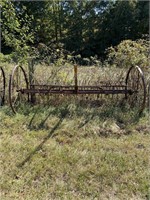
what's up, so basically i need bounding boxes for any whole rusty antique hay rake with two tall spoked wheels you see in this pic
[9,66,146,114]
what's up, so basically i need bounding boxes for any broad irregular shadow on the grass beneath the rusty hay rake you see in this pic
[28,99,140,133]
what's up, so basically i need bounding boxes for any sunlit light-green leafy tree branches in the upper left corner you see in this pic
[1,1,33,61]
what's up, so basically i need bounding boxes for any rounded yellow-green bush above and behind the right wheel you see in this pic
[107,39,149,68]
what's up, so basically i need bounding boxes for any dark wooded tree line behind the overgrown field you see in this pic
[1,0,149,63]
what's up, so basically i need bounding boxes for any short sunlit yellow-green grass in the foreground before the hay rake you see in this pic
[0,101,150,200]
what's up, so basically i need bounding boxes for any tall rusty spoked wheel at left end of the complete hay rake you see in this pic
[9,66,29,113]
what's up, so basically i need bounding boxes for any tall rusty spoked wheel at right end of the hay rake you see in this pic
[126,66,146,115]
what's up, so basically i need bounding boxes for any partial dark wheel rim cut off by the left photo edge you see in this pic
[0,67,6,106]
